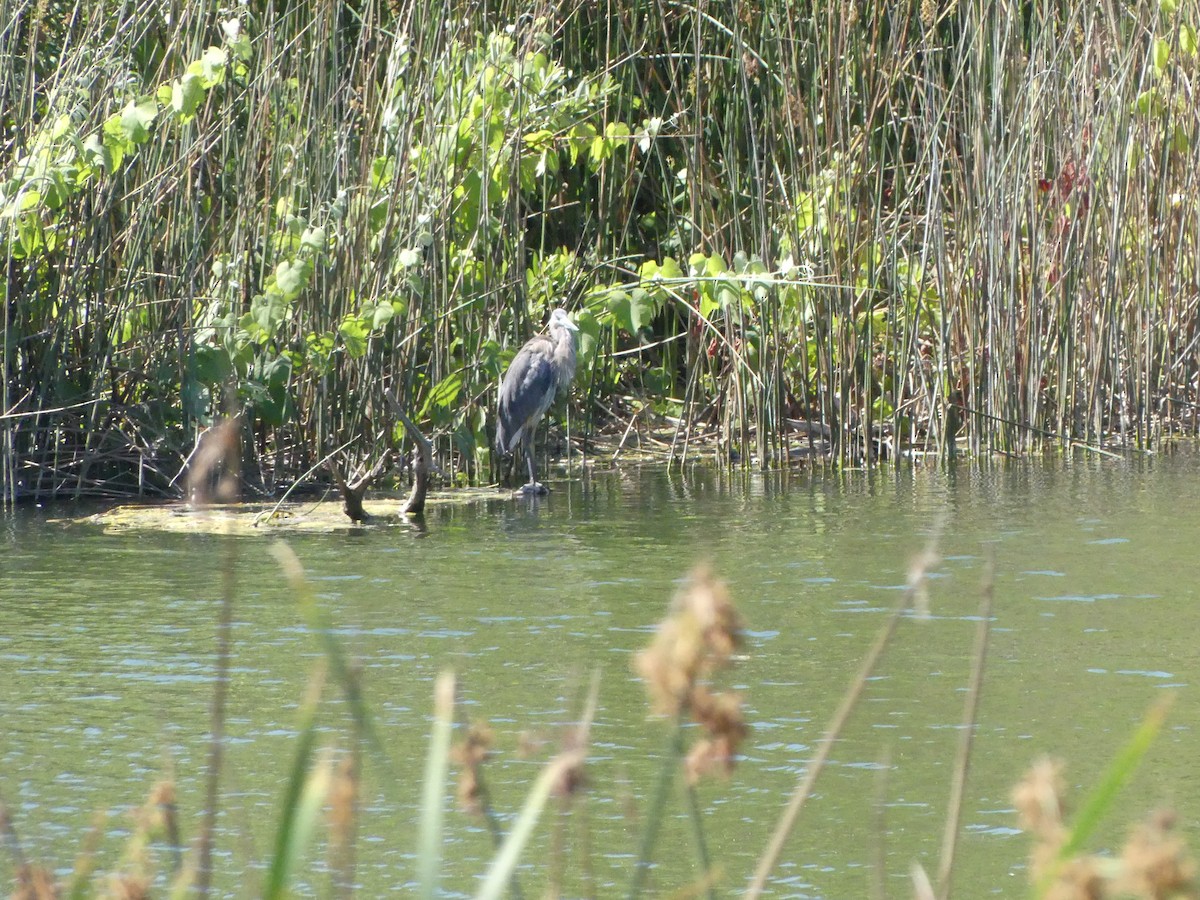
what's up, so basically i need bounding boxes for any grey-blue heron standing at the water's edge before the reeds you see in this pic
[496,310,580,493]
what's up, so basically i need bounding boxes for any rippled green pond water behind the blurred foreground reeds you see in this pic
[0,454,1200,898]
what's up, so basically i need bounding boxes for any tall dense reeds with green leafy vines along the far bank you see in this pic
[0,0,1200,502]
